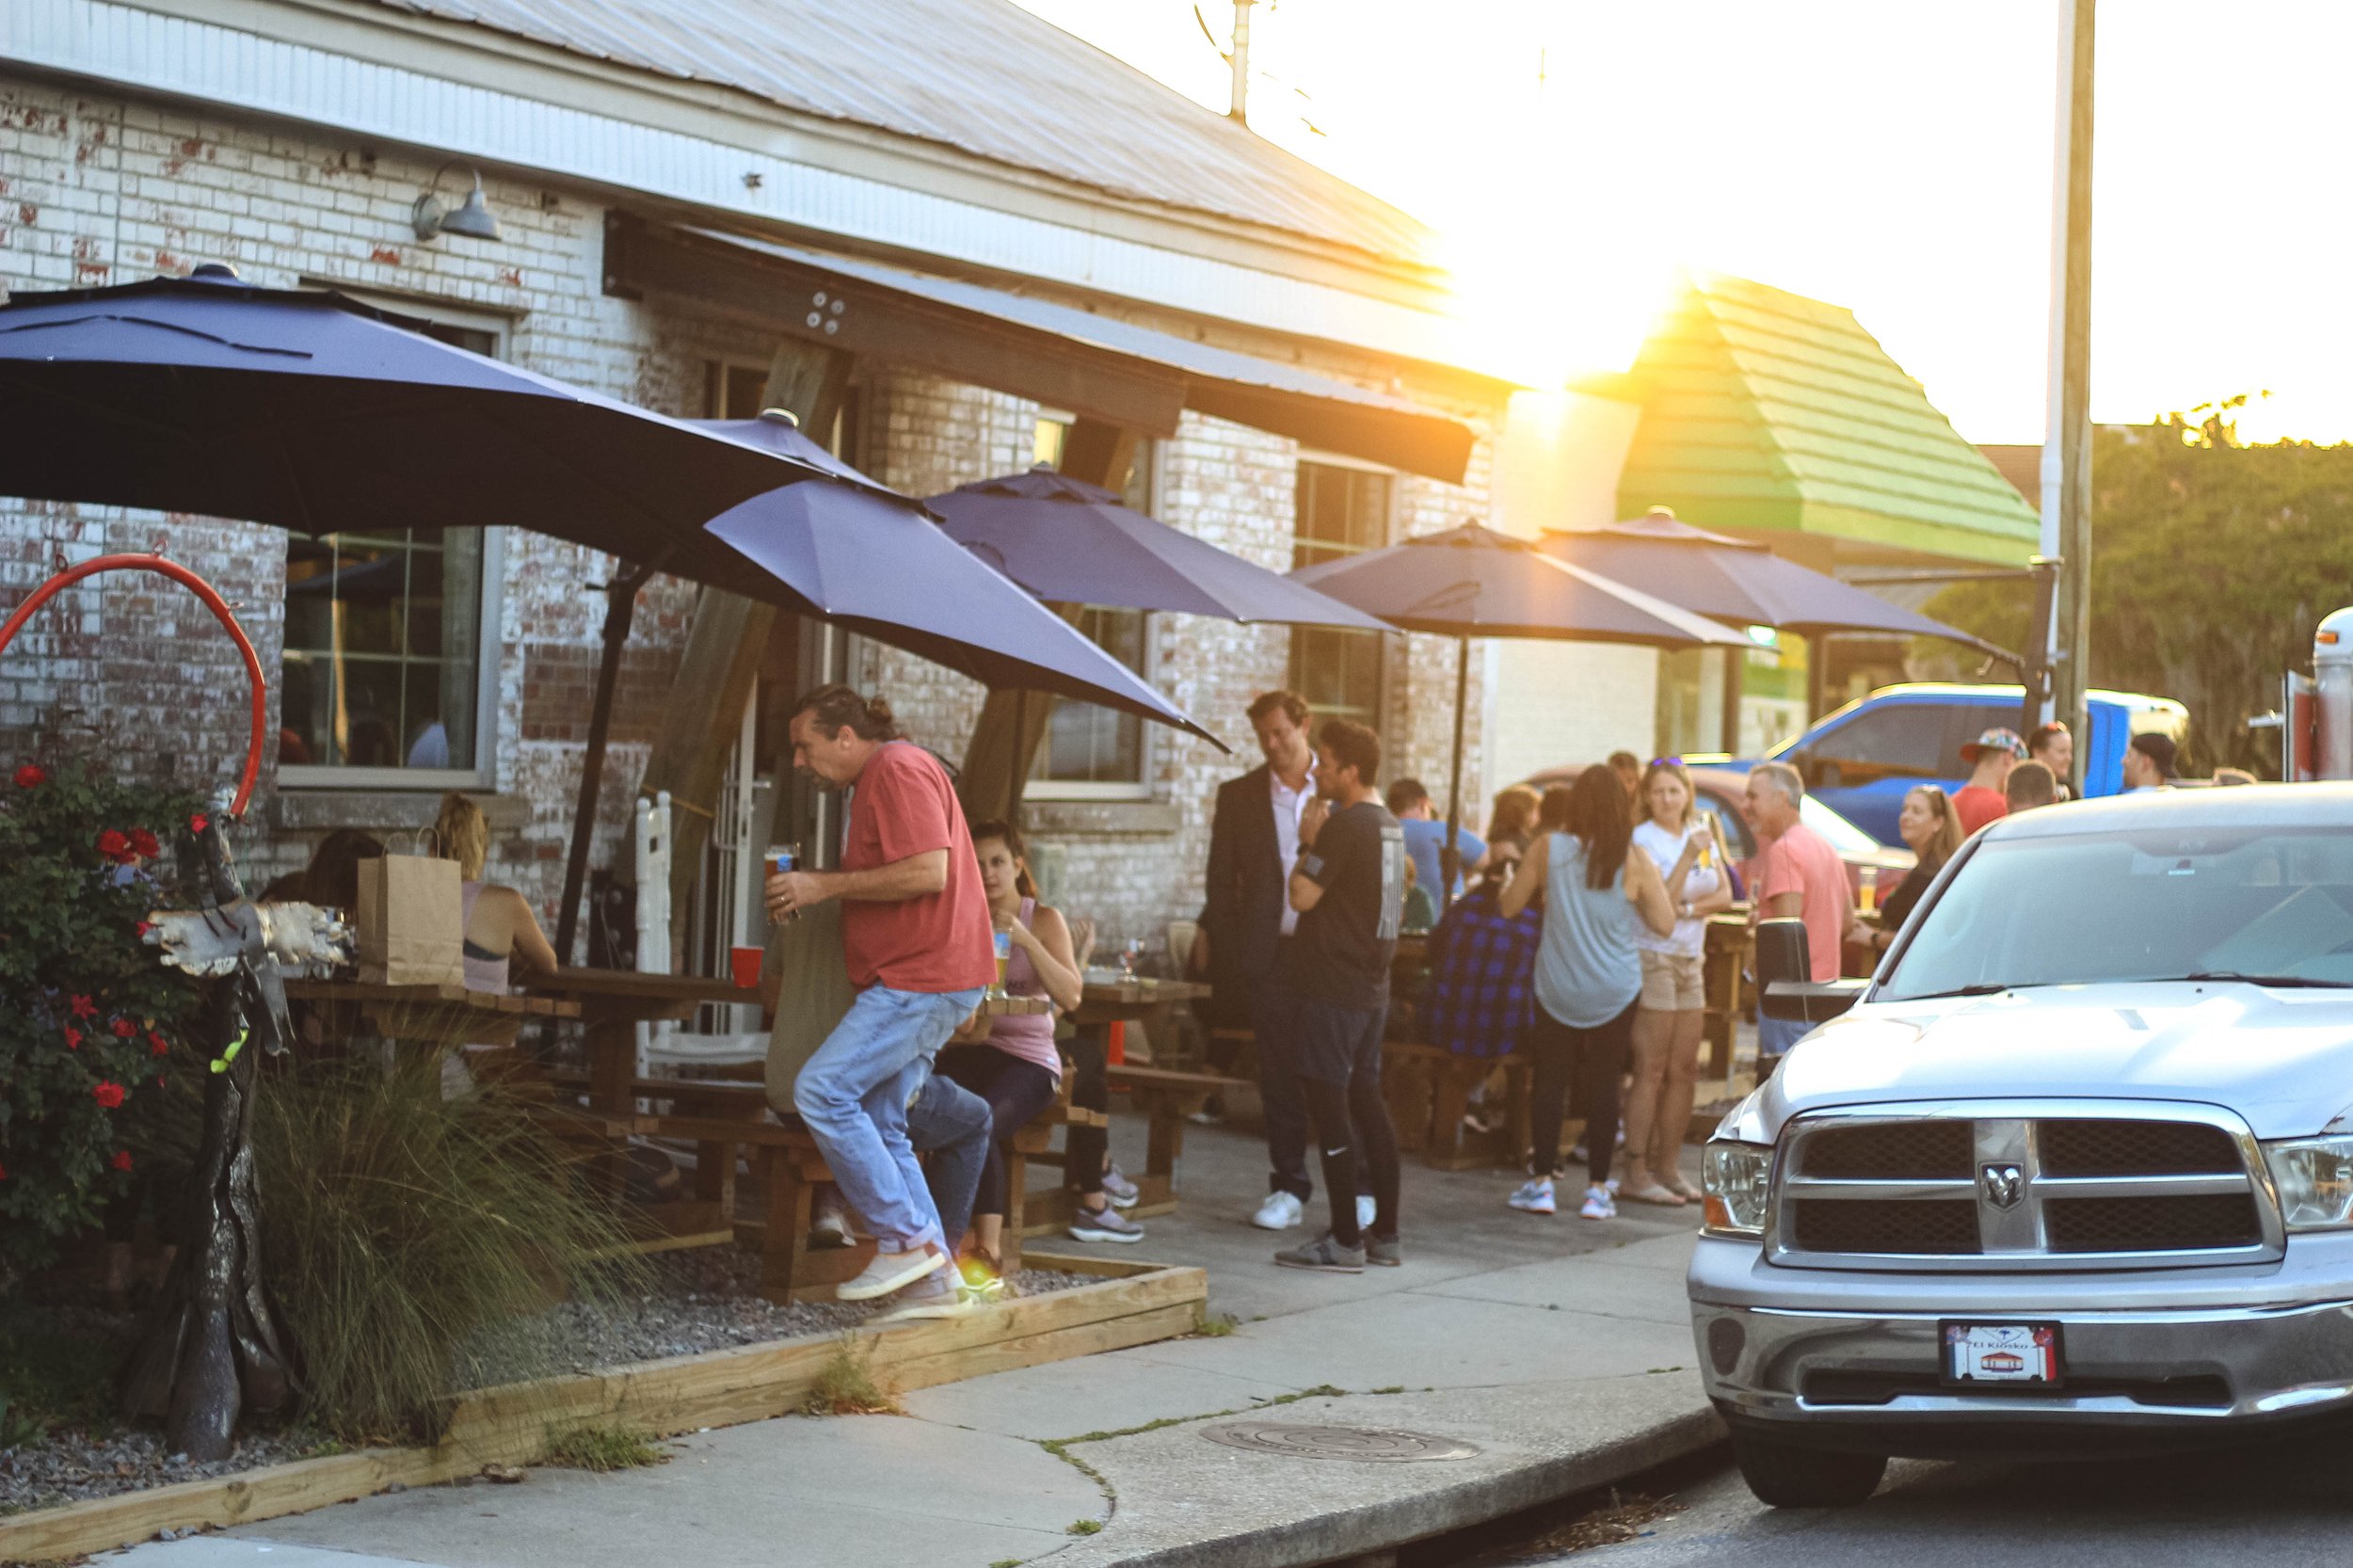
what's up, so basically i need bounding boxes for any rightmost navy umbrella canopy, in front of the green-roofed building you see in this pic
[1542,506,1986,648]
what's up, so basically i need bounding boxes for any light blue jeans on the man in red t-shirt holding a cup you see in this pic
[793,986,984,1253]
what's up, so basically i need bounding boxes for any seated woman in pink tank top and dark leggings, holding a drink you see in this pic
[935,822,1085,1276]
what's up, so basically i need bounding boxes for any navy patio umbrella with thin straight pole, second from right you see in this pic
[1292,522,1749,885]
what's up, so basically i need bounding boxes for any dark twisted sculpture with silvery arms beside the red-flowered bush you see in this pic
[122,801,353,1462]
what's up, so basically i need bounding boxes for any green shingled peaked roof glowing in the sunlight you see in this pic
[1619,276,2041,565]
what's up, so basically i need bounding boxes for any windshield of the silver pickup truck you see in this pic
[1878,826,2353,1000]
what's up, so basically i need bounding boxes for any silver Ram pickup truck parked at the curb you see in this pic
[1689,784,2353,1507]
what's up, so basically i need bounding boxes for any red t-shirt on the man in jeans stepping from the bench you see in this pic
[842,742,998,994]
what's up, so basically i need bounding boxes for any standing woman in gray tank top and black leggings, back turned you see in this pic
[1501,767,1675,1220]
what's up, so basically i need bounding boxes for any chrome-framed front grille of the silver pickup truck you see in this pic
[1768,1102,2282,1269]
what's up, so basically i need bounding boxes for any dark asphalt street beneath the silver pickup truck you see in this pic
[1482,1436,2353,1568]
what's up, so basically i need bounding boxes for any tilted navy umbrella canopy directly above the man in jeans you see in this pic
[706,485,1224,748]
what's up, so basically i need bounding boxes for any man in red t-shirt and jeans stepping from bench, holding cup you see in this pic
[767,685,998,1302]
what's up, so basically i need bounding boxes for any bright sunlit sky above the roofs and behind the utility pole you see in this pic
[1021,0,2353,442]
